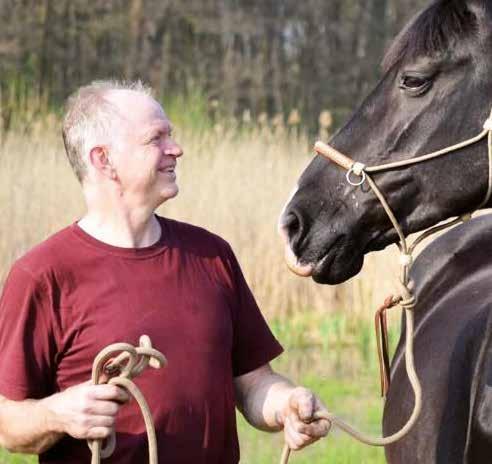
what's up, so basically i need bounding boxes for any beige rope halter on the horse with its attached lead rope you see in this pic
[280,107,492,464]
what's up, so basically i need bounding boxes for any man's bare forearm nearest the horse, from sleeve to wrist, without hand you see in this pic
[238,371,295,432]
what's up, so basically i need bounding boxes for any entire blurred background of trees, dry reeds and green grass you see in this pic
[0,0,430,464]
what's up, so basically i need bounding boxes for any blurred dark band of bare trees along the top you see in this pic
[0,0,428,132]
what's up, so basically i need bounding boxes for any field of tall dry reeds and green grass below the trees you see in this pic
[0,113,408,464]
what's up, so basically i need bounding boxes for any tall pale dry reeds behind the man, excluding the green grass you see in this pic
[0,117,396,318]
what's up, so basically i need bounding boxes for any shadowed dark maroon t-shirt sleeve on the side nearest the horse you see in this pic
[221,246,283,377]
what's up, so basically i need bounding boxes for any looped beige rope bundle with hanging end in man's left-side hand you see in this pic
[87,335,167,464]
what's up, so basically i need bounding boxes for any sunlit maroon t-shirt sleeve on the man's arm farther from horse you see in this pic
[0,265,56,400]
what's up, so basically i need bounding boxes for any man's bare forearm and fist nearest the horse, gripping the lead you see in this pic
[234,364,329,450]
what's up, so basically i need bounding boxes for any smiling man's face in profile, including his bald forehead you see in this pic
[108,91,183,208]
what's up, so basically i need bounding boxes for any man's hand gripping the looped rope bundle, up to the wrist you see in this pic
[39,381,130,439]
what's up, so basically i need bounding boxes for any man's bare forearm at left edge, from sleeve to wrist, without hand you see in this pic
[0,396,63,454]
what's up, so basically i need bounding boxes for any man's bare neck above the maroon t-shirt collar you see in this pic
[78,209,161,248]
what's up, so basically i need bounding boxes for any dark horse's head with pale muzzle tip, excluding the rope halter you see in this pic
[279,0,492,284]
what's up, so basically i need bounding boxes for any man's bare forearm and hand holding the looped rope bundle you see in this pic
[0,382,129,454]
